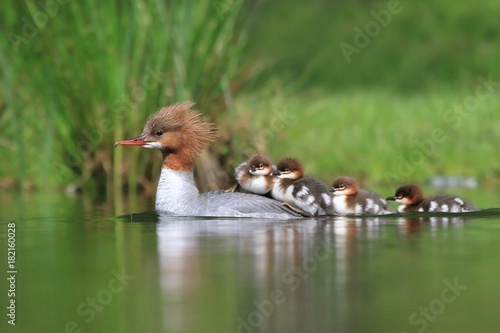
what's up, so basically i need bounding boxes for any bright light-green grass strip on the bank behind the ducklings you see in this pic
[232,87,500,187]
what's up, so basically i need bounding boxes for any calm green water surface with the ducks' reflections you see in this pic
[0,193,500,333]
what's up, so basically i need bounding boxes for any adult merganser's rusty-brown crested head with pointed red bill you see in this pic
[115,102,219,171]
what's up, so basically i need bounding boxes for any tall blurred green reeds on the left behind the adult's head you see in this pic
[0,0,248,202]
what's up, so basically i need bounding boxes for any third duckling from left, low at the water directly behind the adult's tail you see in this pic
[330,177,395,215]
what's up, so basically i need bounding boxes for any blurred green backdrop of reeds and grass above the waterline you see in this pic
[0,0,500,208]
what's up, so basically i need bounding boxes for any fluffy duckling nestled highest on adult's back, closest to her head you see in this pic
[234,154,275,195]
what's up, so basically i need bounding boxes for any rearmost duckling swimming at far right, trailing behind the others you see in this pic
[386,185,478,213]
